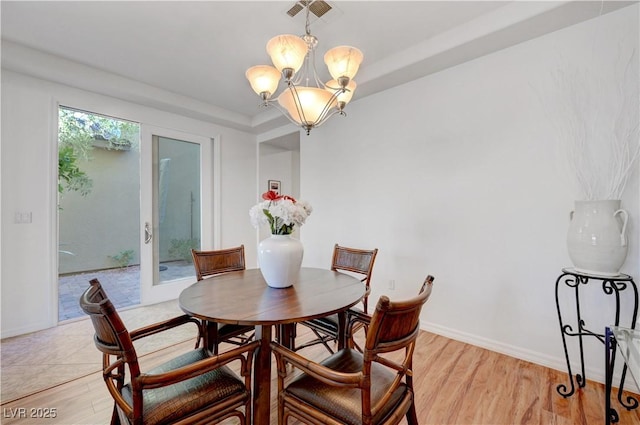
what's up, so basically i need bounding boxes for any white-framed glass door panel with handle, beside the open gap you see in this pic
[140,125,213,304]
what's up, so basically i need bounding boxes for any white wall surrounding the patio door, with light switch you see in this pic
[1,68,257,338]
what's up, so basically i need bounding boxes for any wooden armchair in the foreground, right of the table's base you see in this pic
[271,279,433,425]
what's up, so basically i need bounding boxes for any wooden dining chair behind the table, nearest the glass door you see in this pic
[191,245,254,353]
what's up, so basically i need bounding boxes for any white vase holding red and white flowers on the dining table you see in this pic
[258,235,304,288]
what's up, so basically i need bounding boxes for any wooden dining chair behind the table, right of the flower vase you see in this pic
[294,244,378,353]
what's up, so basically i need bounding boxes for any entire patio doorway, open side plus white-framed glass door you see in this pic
[58,111,213,321]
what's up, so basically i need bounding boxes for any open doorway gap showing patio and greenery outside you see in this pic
[58,106,140,321]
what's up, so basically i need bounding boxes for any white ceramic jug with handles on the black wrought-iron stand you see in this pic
[567,200,629,276]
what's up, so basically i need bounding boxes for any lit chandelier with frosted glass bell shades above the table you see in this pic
[245,1,363,135]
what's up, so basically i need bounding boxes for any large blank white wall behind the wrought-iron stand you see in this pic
[300,4,640,379]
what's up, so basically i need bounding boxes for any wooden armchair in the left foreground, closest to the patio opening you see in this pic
[80,279,259,425]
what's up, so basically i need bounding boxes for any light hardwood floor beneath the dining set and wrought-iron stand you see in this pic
[1,310,640,425]
